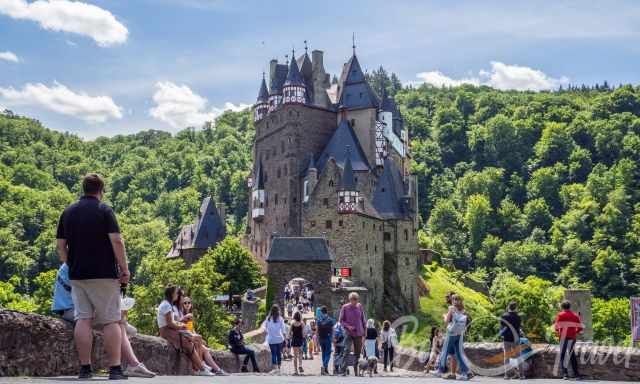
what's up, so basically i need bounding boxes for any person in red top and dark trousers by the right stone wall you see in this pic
[555,300,583,380]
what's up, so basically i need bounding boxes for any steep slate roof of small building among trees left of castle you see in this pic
[167,196,227,258]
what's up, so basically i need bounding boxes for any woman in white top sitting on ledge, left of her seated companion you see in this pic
[156,285,213,376]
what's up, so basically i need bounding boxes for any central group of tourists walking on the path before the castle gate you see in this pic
[262,290,398,376]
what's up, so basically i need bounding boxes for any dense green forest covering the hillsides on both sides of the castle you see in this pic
[0,78,640,341]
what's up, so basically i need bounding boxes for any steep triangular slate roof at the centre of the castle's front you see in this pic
[316,119,371,172]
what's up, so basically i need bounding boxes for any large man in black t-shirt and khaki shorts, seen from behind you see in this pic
[56,173,129,380]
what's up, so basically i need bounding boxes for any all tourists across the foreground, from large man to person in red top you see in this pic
[52,174,582,380]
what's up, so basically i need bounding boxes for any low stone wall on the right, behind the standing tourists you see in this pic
[395,343,640,382]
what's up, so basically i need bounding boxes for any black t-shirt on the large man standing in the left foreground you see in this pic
[56,196,120,280]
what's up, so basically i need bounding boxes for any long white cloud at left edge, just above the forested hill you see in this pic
[0,82,122,123]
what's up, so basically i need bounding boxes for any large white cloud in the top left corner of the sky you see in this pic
[0,0,129,47]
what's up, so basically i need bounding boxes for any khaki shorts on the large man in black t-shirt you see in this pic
[71,279,122,325]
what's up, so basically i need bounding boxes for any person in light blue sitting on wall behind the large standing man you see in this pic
[52,263,156,378]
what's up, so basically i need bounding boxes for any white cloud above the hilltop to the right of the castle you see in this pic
[413,61,569,91]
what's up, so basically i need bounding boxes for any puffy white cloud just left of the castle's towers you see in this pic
[149,81,249,128]
